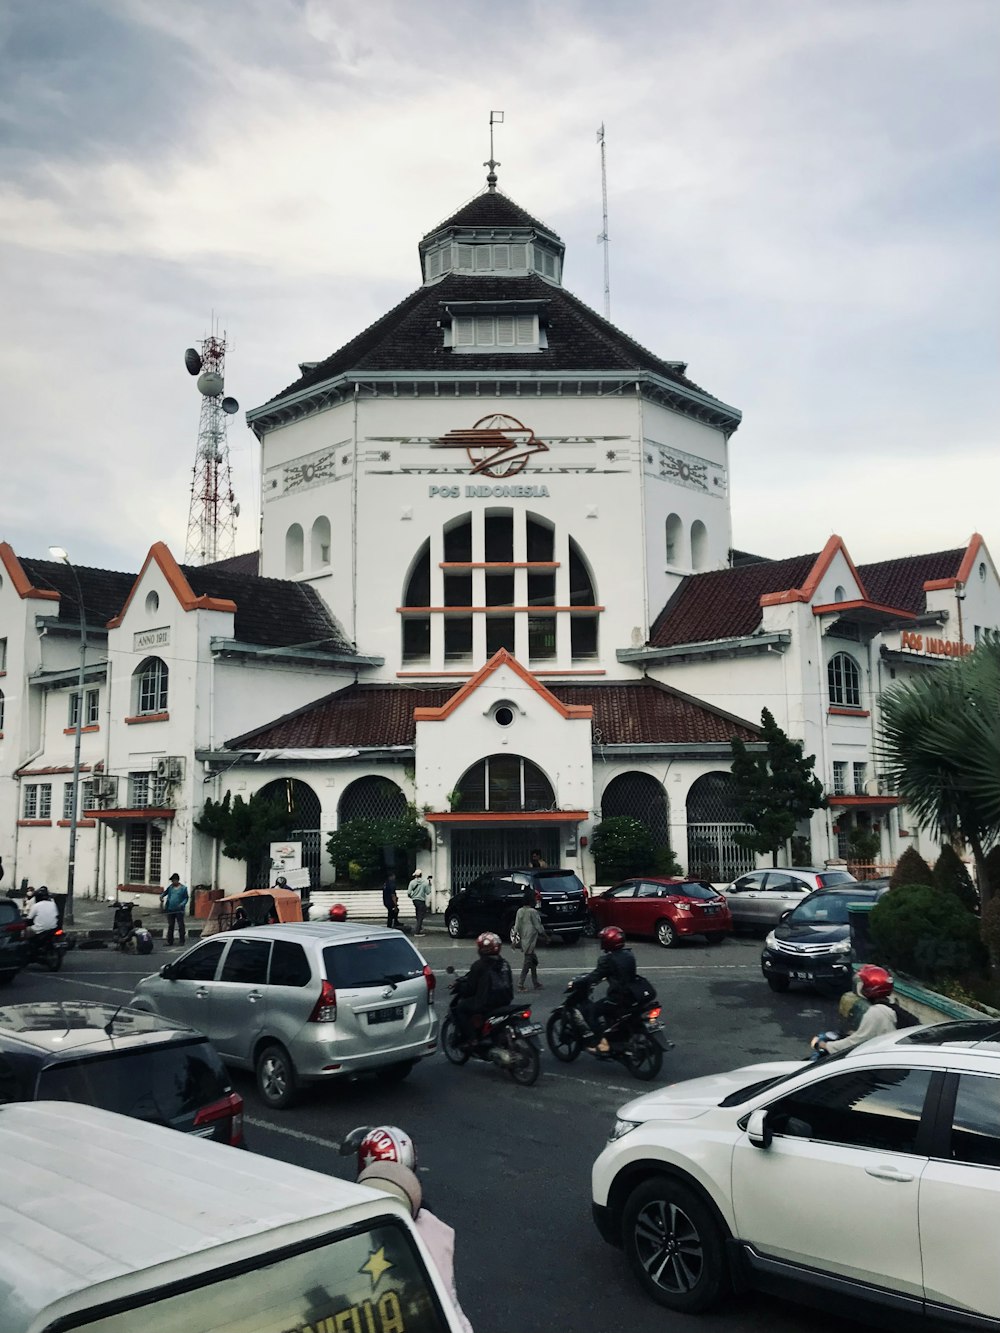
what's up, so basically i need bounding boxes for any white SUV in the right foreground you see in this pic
[592,1020,1000,1330]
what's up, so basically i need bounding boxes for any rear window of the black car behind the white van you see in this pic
[37,1041,229,1125]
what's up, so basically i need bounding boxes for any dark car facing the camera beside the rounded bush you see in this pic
[760,880,889,992]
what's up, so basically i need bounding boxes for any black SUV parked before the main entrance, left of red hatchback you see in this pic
[444,868,587,944]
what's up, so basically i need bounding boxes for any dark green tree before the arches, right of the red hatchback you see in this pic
[731,708,823,865]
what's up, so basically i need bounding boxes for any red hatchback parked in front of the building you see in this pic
[589,876,732,949]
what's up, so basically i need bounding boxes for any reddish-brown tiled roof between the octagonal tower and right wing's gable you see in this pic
[649,556,819,648]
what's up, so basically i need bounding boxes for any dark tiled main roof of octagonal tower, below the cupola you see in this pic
[271,273,705,403]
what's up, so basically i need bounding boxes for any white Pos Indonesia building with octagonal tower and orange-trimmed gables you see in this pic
[0,174,1000,893]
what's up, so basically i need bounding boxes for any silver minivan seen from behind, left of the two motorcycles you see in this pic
[132,921,437,1108]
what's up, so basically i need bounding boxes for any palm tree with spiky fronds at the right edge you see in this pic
[879,633,1000,902]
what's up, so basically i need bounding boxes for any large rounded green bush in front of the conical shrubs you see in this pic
[869,884,987,982]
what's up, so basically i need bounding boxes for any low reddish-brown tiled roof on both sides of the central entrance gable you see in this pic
[227,680,757,749]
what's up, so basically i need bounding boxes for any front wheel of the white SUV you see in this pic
[623,1176,729,1314]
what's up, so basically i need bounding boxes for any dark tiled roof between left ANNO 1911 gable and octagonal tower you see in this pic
[181,565,355,653]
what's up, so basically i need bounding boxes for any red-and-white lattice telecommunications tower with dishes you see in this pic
[184,333,240,565]
